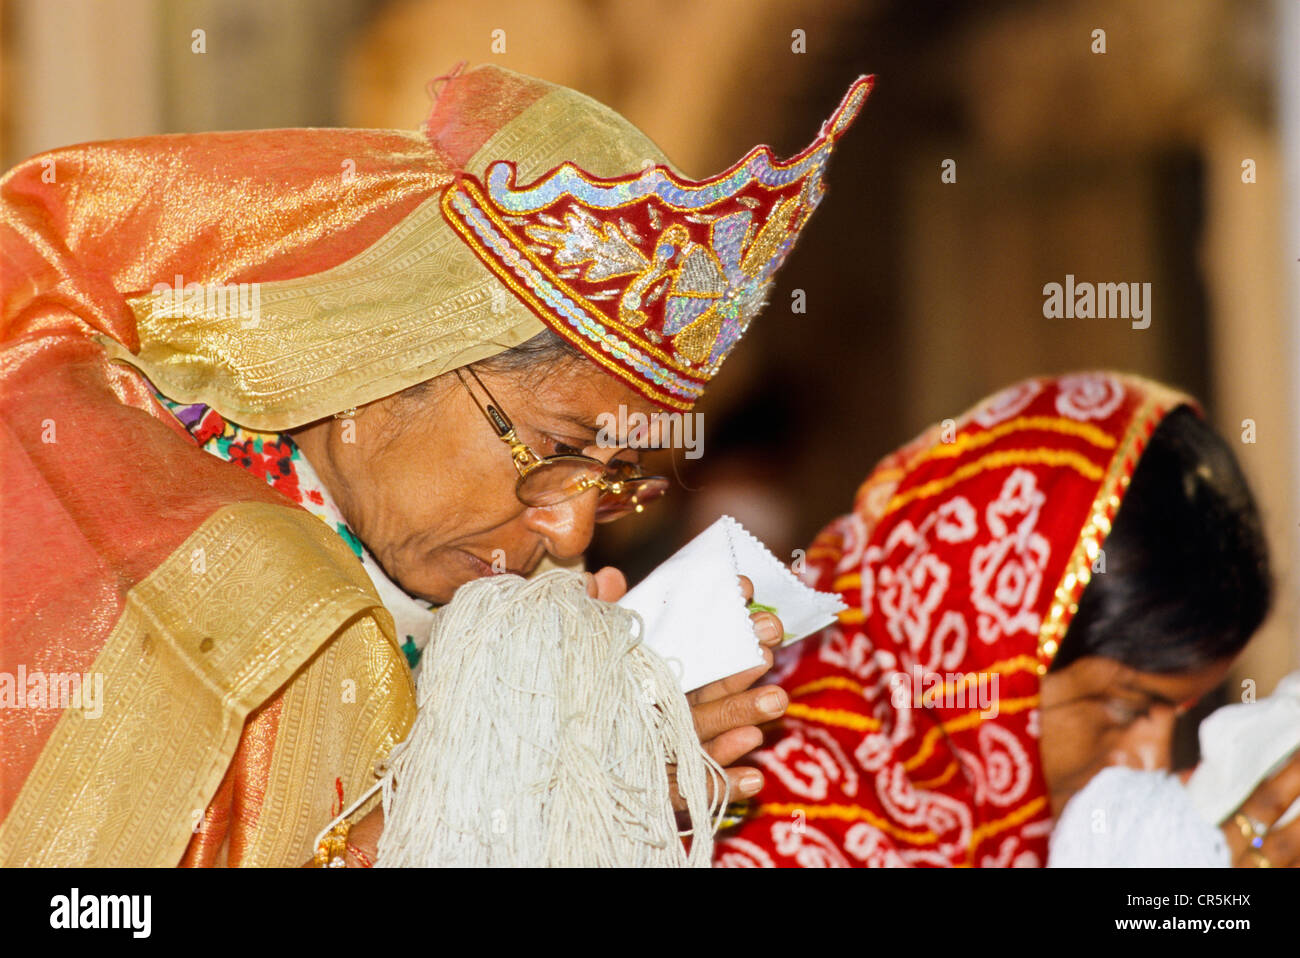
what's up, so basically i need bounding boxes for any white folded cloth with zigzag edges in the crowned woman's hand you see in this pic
[619,516,845,692]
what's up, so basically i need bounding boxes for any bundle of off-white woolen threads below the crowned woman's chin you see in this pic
[377,569,727,867]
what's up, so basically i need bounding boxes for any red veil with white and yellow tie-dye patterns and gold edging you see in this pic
[715,373,1195,867]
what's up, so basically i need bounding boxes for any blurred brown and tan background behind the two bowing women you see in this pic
[0,0,1300,743]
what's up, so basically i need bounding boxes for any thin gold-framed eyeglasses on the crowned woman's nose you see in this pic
[456,367,668,523]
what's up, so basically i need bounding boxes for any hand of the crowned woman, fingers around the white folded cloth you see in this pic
[586,567,789,811]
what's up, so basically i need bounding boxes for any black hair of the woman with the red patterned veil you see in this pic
[1052,407,1273,675]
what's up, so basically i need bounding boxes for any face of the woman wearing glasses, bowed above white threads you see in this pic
[295,361,655,603]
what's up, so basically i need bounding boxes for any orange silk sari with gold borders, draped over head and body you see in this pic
[0,61,660,866]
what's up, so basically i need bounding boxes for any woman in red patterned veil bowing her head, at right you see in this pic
[716,373,1300,867]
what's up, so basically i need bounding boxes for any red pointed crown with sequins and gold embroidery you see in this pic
[442,77,874,409]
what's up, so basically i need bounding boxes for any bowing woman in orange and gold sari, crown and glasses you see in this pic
[0,66,870,866]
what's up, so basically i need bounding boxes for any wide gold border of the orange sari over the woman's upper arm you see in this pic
[0,503,415,866]
